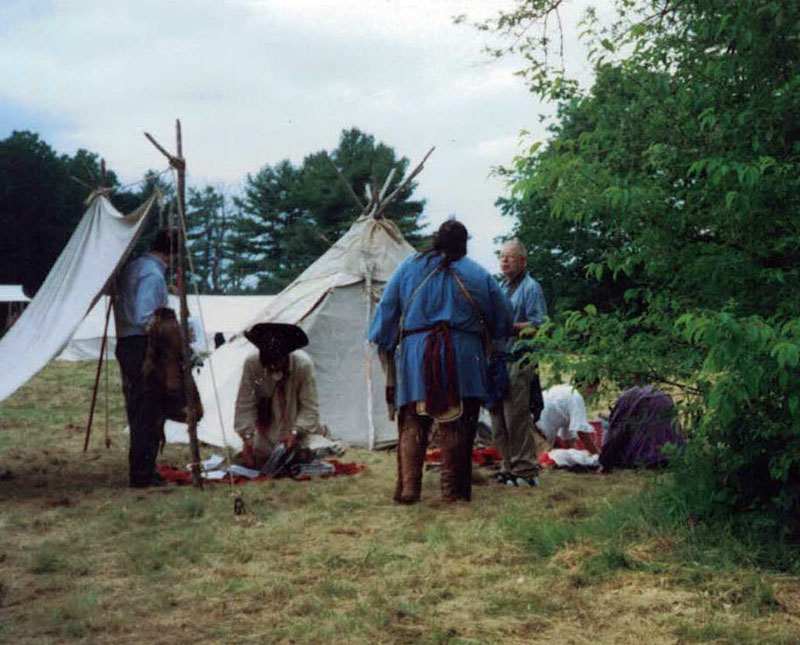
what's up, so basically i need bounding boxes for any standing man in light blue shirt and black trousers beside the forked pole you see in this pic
[114,229,178,488]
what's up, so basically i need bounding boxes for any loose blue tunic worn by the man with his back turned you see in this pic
[369,254,512,408]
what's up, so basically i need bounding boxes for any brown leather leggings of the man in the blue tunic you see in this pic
[394,399,480,504]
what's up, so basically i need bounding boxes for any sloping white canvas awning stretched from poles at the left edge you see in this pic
[0,195,155,401]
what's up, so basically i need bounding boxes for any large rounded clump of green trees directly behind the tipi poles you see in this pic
[231,128,424,292]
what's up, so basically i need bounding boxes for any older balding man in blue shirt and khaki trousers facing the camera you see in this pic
[492,240,547,486]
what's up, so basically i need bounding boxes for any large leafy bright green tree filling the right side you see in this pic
[488,0,800,534]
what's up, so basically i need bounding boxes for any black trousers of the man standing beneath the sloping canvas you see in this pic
[115,336,164,486]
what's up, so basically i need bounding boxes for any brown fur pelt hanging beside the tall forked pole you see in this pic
[142,307,203,422]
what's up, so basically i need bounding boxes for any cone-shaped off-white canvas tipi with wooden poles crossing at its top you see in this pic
[166,150,432,449]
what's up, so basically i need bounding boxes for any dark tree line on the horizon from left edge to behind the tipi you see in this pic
[0,128,425,295]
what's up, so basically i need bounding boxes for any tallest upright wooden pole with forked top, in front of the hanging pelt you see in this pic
[144,119,203,488]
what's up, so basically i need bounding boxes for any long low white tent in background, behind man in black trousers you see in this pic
[58,295,274,361]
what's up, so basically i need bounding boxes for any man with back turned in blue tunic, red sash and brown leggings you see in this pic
[369,219,512,504]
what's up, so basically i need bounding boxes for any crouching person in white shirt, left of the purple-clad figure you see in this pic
[536,383,600,455]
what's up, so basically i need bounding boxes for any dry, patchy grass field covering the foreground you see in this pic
[0,363,800,644]
